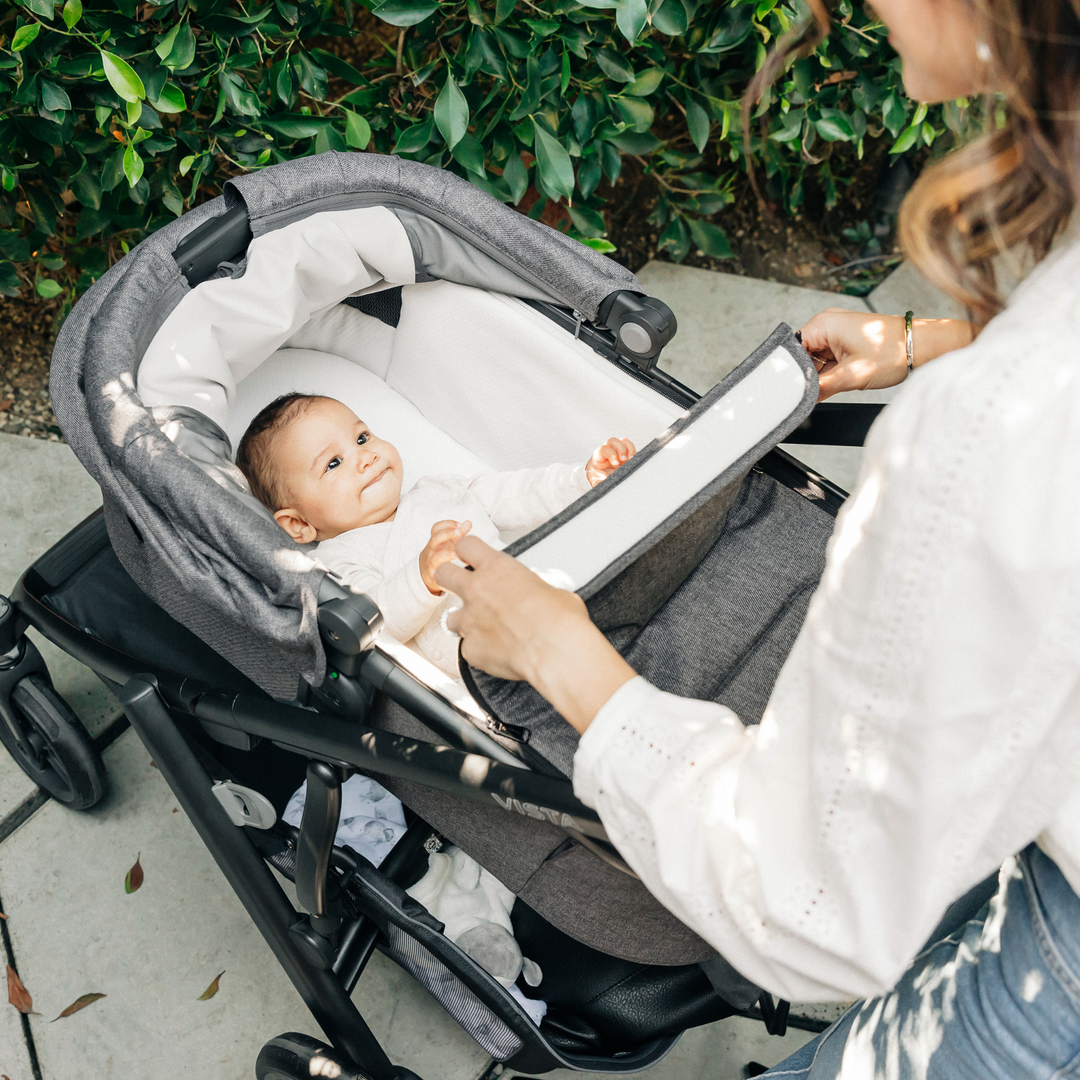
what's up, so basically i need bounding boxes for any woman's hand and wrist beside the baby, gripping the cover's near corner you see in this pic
[435,537,635,731]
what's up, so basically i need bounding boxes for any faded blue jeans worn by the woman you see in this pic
[765,845,1080,1080]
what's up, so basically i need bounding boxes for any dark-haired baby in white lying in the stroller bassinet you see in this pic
[237,394,636,678]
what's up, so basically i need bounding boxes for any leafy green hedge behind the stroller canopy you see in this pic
[0,0,963,302]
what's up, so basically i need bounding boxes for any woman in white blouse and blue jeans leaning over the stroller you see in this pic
[438,0,1080,1080]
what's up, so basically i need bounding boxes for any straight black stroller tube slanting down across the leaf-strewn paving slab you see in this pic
[120,676,402,1080]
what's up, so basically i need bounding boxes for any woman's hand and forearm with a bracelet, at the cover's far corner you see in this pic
[801,308,973,401]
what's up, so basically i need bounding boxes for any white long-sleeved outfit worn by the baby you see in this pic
[319,464,590,678]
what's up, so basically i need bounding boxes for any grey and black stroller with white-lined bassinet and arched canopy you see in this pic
[0,152,878,1080]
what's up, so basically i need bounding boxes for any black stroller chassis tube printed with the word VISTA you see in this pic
[188,693,610,842]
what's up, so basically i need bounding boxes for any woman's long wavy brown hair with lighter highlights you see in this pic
[744,0,1080,327]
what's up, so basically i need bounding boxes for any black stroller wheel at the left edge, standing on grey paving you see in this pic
[0,673,106,810]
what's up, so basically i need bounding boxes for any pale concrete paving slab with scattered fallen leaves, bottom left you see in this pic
[0,731,489,1080]
